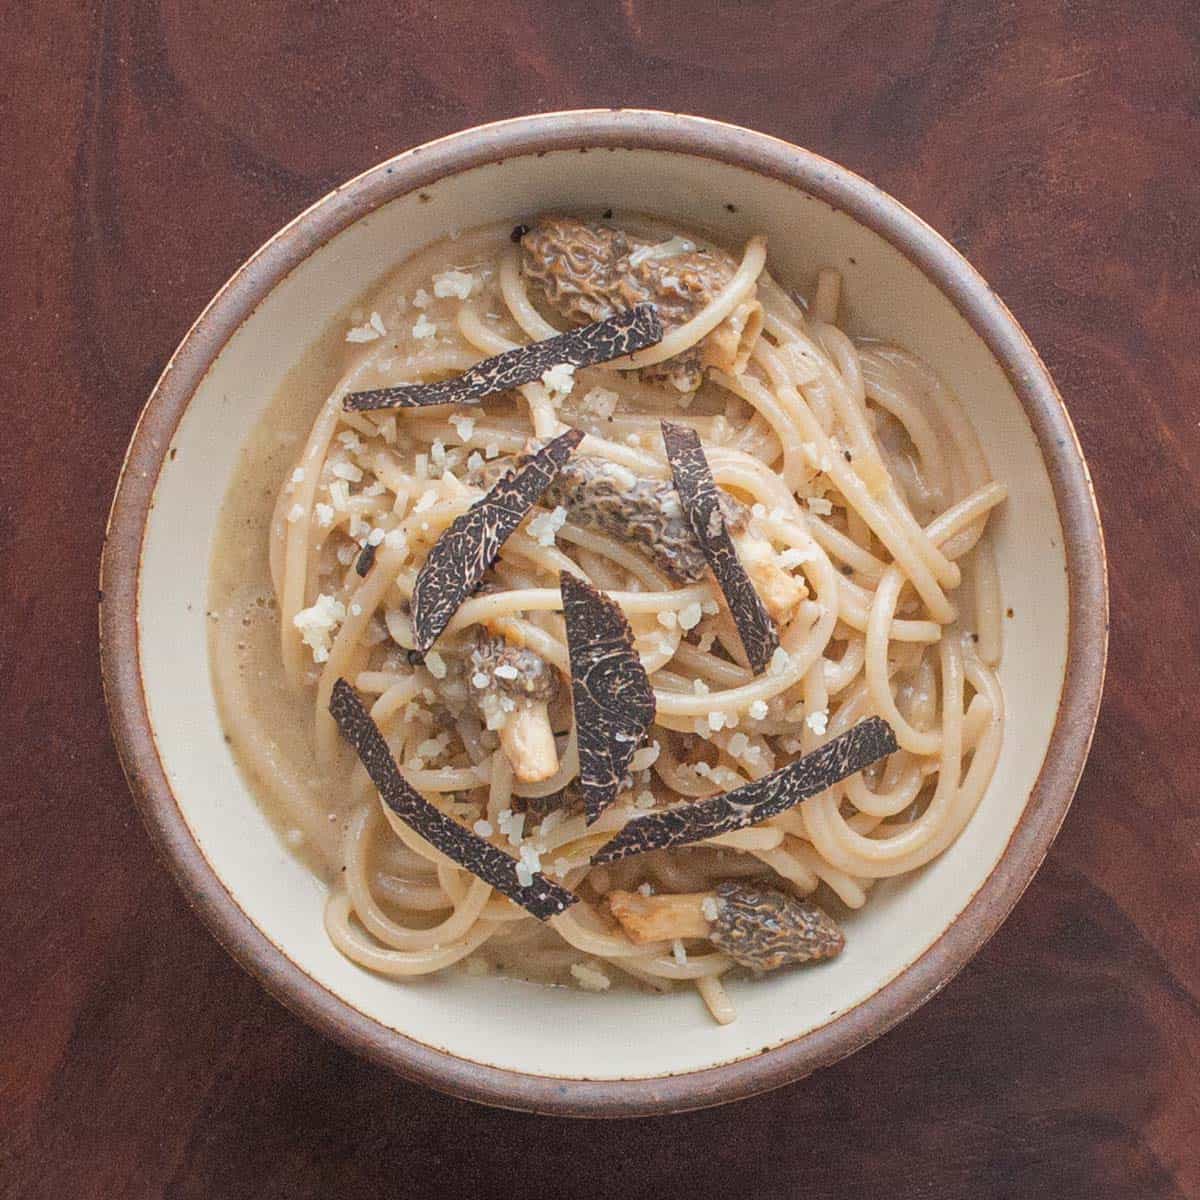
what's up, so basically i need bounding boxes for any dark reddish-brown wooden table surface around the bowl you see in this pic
[0,0,1200,1200]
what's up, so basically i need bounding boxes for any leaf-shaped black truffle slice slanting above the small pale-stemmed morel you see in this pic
[413,430,583,654]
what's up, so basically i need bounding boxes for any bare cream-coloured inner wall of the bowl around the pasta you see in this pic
[139,150,1068,1079]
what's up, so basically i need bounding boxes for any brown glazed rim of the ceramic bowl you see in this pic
[100,109,1108,1116]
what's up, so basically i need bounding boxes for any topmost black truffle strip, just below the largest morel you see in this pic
[342,304,662,413]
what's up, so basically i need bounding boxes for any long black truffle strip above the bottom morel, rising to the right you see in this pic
[592,716,898,864]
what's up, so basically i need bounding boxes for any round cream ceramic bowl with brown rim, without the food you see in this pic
[101,110,1108,1116]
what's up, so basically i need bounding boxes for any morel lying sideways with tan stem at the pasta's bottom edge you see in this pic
[608,880,846,971]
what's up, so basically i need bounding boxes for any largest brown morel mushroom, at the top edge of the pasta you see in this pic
[521,216,762,392]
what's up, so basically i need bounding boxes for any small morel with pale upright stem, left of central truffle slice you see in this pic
[468,631,558,784]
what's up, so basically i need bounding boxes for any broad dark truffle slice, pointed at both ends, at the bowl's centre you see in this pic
[558,571,654,824]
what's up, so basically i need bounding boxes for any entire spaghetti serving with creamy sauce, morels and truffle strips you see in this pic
[210,211,1006,1024]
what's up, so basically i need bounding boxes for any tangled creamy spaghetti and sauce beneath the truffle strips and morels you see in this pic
[212,221,1004,1022]
